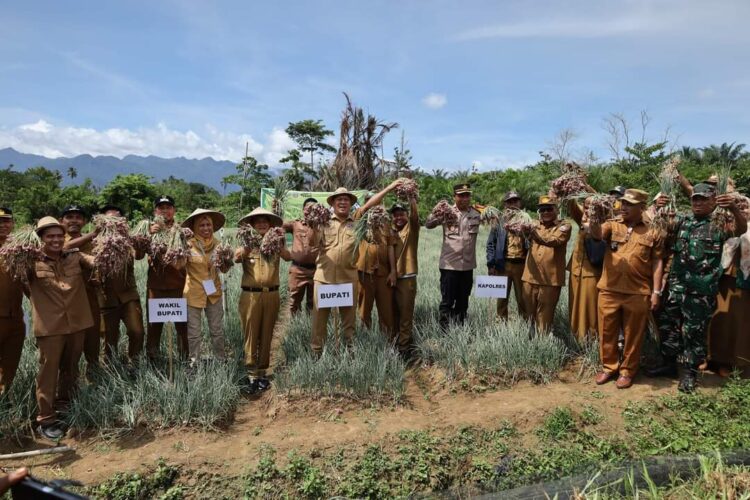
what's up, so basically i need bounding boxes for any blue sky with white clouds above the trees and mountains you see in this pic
[0,0,750,170]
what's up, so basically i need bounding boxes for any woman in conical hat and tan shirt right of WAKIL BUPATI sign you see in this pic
[182,208,229,364]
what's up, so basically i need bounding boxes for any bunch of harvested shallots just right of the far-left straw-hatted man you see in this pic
[92,215,133,278]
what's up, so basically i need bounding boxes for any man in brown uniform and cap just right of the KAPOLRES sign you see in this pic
[521,195,570,333]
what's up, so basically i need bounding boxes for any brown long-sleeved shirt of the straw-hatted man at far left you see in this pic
[29,250,98,337]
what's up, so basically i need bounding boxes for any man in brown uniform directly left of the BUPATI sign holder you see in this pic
[284,198,318,314]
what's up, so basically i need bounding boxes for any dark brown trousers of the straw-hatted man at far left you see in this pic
[36,330,86,424]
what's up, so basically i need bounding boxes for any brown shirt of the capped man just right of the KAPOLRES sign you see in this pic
[521,221,571,286]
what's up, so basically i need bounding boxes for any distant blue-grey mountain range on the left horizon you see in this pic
[0,148,275,192]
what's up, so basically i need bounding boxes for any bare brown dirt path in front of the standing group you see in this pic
[0,370,718,484]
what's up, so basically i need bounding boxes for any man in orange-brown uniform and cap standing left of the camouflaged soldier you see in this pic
[589,189,663,389]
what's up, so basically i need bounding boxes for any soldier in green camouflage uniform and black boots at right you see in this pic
[657,183,747,393]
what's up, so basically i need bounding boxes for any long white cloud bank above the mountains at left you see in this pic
[0,120,294,165]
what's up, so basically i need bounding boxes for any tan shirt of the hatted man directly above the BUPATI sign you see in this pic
[313,211,361,283]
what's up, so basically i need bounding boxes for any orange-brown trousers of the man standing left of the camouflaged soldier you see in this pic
[599,290,651,378]
